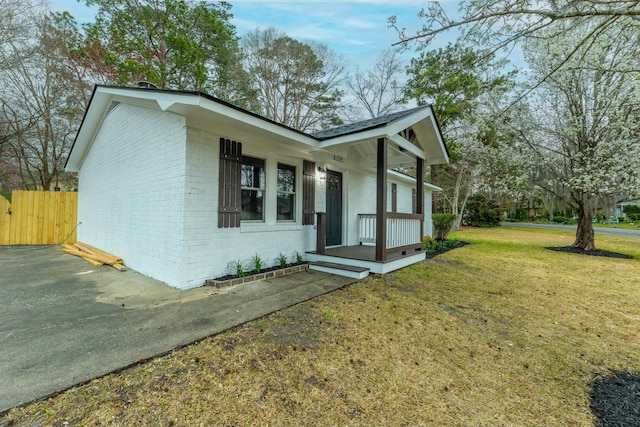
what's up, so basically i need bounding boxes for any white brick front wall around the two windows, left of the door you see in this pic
[183,127,316,287]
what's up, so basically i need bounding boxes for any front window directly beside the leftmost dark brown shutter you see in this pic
[240,156,266,221]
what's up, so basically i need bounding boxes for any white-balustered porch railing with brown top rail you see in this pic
[358,212,422,250]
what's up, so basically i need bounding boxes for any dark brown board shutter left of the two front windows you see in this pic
[218,138,242,228]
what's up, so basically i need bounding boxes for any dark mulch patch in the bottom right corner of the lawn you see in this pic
[590,371,640,427]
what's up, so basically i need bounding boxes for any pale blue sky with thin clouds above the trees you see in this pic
[52,0,457,70]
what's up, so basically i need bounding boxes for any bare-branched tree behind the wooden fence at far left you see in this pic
[0,13,88,190]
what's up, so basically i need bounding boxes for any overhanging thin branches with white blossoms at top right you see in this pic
[389,0,640,105]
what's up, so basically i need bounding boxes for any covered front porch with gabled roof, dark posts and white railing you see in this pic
[307,106,448,278]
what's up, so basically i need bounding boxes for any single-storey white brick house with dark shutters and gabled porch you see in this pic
[66,86,448,289]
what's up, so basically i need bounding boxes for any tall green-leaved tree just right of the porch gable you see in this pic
[405,43,515,221]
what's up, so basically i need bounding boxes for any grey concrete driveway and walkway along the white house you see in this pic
[0,246,354,413]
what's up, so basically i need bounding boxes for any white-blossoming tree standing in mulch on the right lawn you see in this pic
[520,22,640,251]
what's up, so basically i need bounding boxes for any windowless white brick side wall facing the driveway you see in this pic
[78,104,185,287]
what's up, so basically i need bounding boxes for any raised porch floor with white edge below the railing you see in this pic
[307,245,425,274]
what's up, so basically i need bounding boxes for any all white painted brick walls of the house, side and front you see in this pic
[78,104,440,289]
